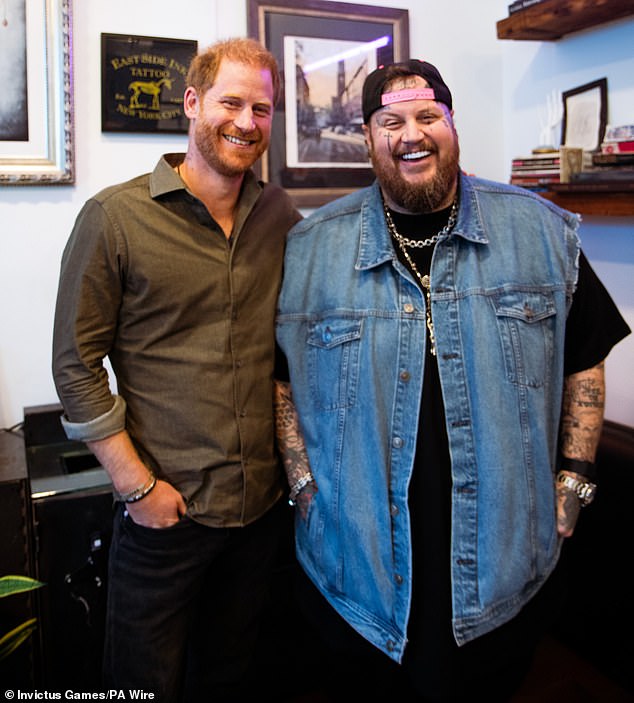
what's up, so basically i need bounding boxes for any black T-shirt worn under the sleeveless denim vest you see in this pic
[392,204,629,696]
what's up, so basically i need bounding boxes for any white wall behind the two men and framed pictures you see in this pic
[0,0,634,427]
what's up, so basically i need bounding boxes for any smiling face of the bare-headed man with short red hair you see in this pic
[185,59,274,177]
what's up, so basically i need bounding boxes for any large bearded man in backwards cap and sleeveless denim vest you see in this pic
[276,60,629,701]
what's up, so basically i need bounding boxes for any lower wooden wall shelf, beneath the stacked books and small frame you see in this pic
[540,183,634,217]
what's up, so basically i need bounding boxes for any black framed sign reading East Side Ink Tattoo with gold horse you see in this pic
[101,33,198,134]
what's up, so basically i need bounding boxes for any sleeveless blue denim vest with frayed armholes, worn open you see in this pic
[277,175,579,661]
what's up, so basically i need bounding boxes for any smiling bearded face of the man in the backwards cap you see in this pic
[364,76,460,213]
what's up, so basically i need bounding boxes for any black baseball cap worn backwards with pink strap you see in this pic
[362,59,453,124]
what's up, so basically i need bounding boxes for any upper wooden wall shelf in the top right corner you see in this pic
[497,0,634,41]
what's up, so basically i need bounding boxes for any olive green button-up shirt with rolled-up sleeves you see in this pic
[53,155,301,527]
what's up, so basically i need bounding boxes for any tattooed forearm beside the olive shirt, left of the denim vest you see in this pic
[273,381,310,485]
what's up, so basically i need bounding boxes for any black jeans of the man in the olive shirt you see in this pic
[104,502,284,703]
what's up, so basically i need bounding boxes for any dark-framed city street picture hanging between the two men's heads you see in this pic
[247,0,409,207]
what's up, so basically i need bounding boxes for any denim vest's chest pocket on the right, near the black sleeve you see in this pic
[495,291,555,388]
